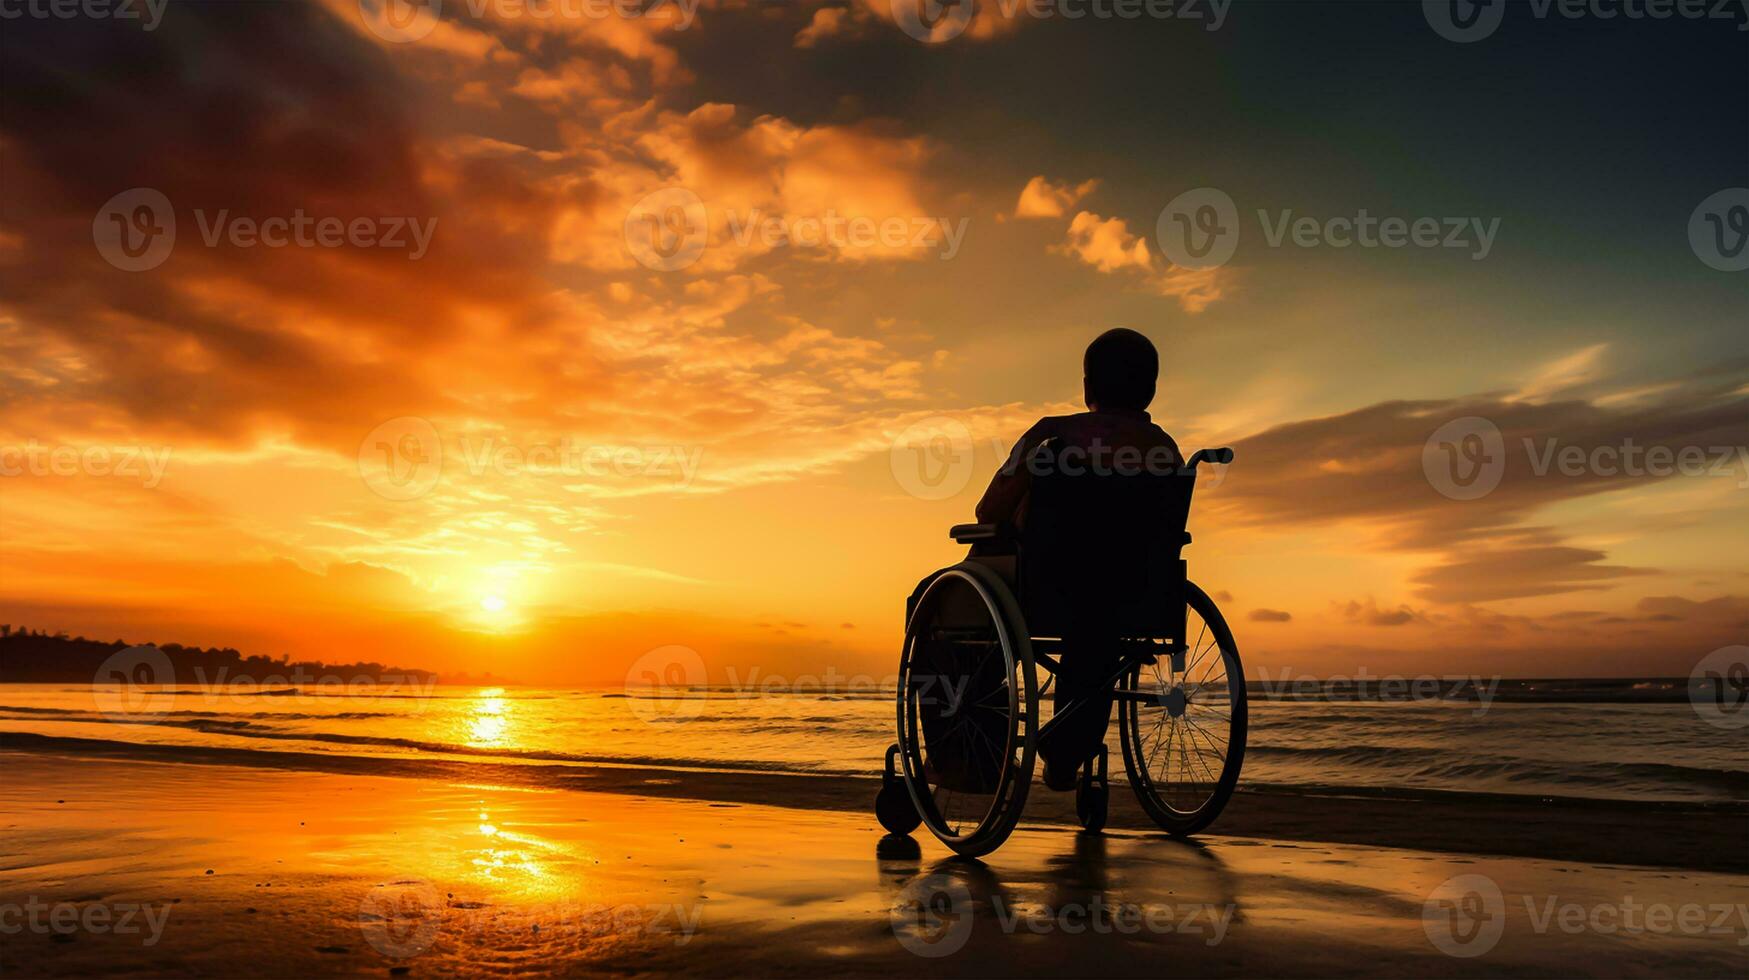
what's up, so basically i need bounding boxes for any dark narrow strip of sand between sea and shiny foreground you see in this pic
[0,732,1749,873]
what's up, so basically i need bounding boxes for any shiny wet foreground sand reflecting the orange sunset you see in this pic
[0,751,1749,977]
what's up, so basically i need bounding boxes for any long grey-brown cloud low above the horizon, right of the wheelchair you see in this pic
[1207,374,1749,602]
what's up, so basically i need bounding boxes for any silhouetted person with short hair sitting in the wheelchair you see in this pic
[978,327,1184,789]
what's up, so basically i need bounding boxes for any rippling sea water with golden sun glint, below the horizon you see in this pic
[0,681,1749,803]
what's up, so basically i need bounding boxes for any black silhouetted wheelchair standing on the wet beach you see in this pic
[875,445,1247,858]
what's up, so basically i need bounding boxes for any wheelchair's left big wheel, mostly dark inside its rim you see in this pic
[899,562,1039,858]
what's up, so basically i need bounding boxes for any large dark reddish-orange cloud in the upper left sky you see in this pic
[0,4,566,445]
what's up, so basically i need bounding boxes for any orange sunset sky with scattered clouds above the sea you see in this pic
[0,0,1749,684]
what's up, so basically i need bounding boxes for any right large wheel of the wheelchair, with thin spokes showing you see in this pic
[1116,583,1247,835]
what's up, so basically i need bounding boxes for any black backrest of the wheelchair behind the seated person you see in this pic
[1018,441,1196,642]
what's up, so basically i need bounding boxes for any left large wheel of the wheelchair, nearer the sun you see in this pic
[897,565,1037,854]
